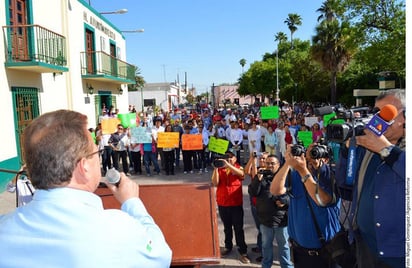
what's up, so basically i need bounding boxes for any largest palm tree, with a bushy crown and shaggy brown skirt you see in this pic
[311,20,355,105]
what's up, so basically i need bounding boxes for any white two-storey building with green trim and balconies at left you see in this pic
[0,0,136,189]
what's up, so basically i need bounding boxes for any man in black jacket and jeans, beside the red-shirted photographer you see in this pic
[249,155,293,268]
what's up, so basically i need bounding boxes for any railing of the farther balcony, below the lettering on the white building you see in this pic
[81,51,136,84]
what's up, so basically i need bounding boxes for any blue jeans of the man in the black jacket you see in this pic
[260,224,293,268]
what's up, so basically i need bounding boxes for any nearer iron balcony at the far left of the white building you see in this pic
[3,25,68,73]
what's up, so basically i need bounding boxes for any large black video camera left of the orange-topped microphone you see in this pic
[315,107,373,143]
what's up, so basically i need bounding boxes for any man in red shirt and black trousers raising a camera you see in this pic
[212,151,250,263]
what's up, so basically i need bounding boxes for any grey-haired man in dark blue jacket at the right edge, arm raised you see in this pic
[336,89,406,268]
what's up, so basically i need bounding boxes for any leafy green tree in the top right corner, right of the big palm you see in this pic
[345,0,406,81]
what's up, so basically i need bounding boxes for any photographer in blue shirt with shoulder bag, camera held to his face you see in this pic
[270,144,341,268]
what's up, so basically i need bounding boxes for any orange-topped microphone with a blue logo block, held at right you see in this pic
[366,104,398,136]
